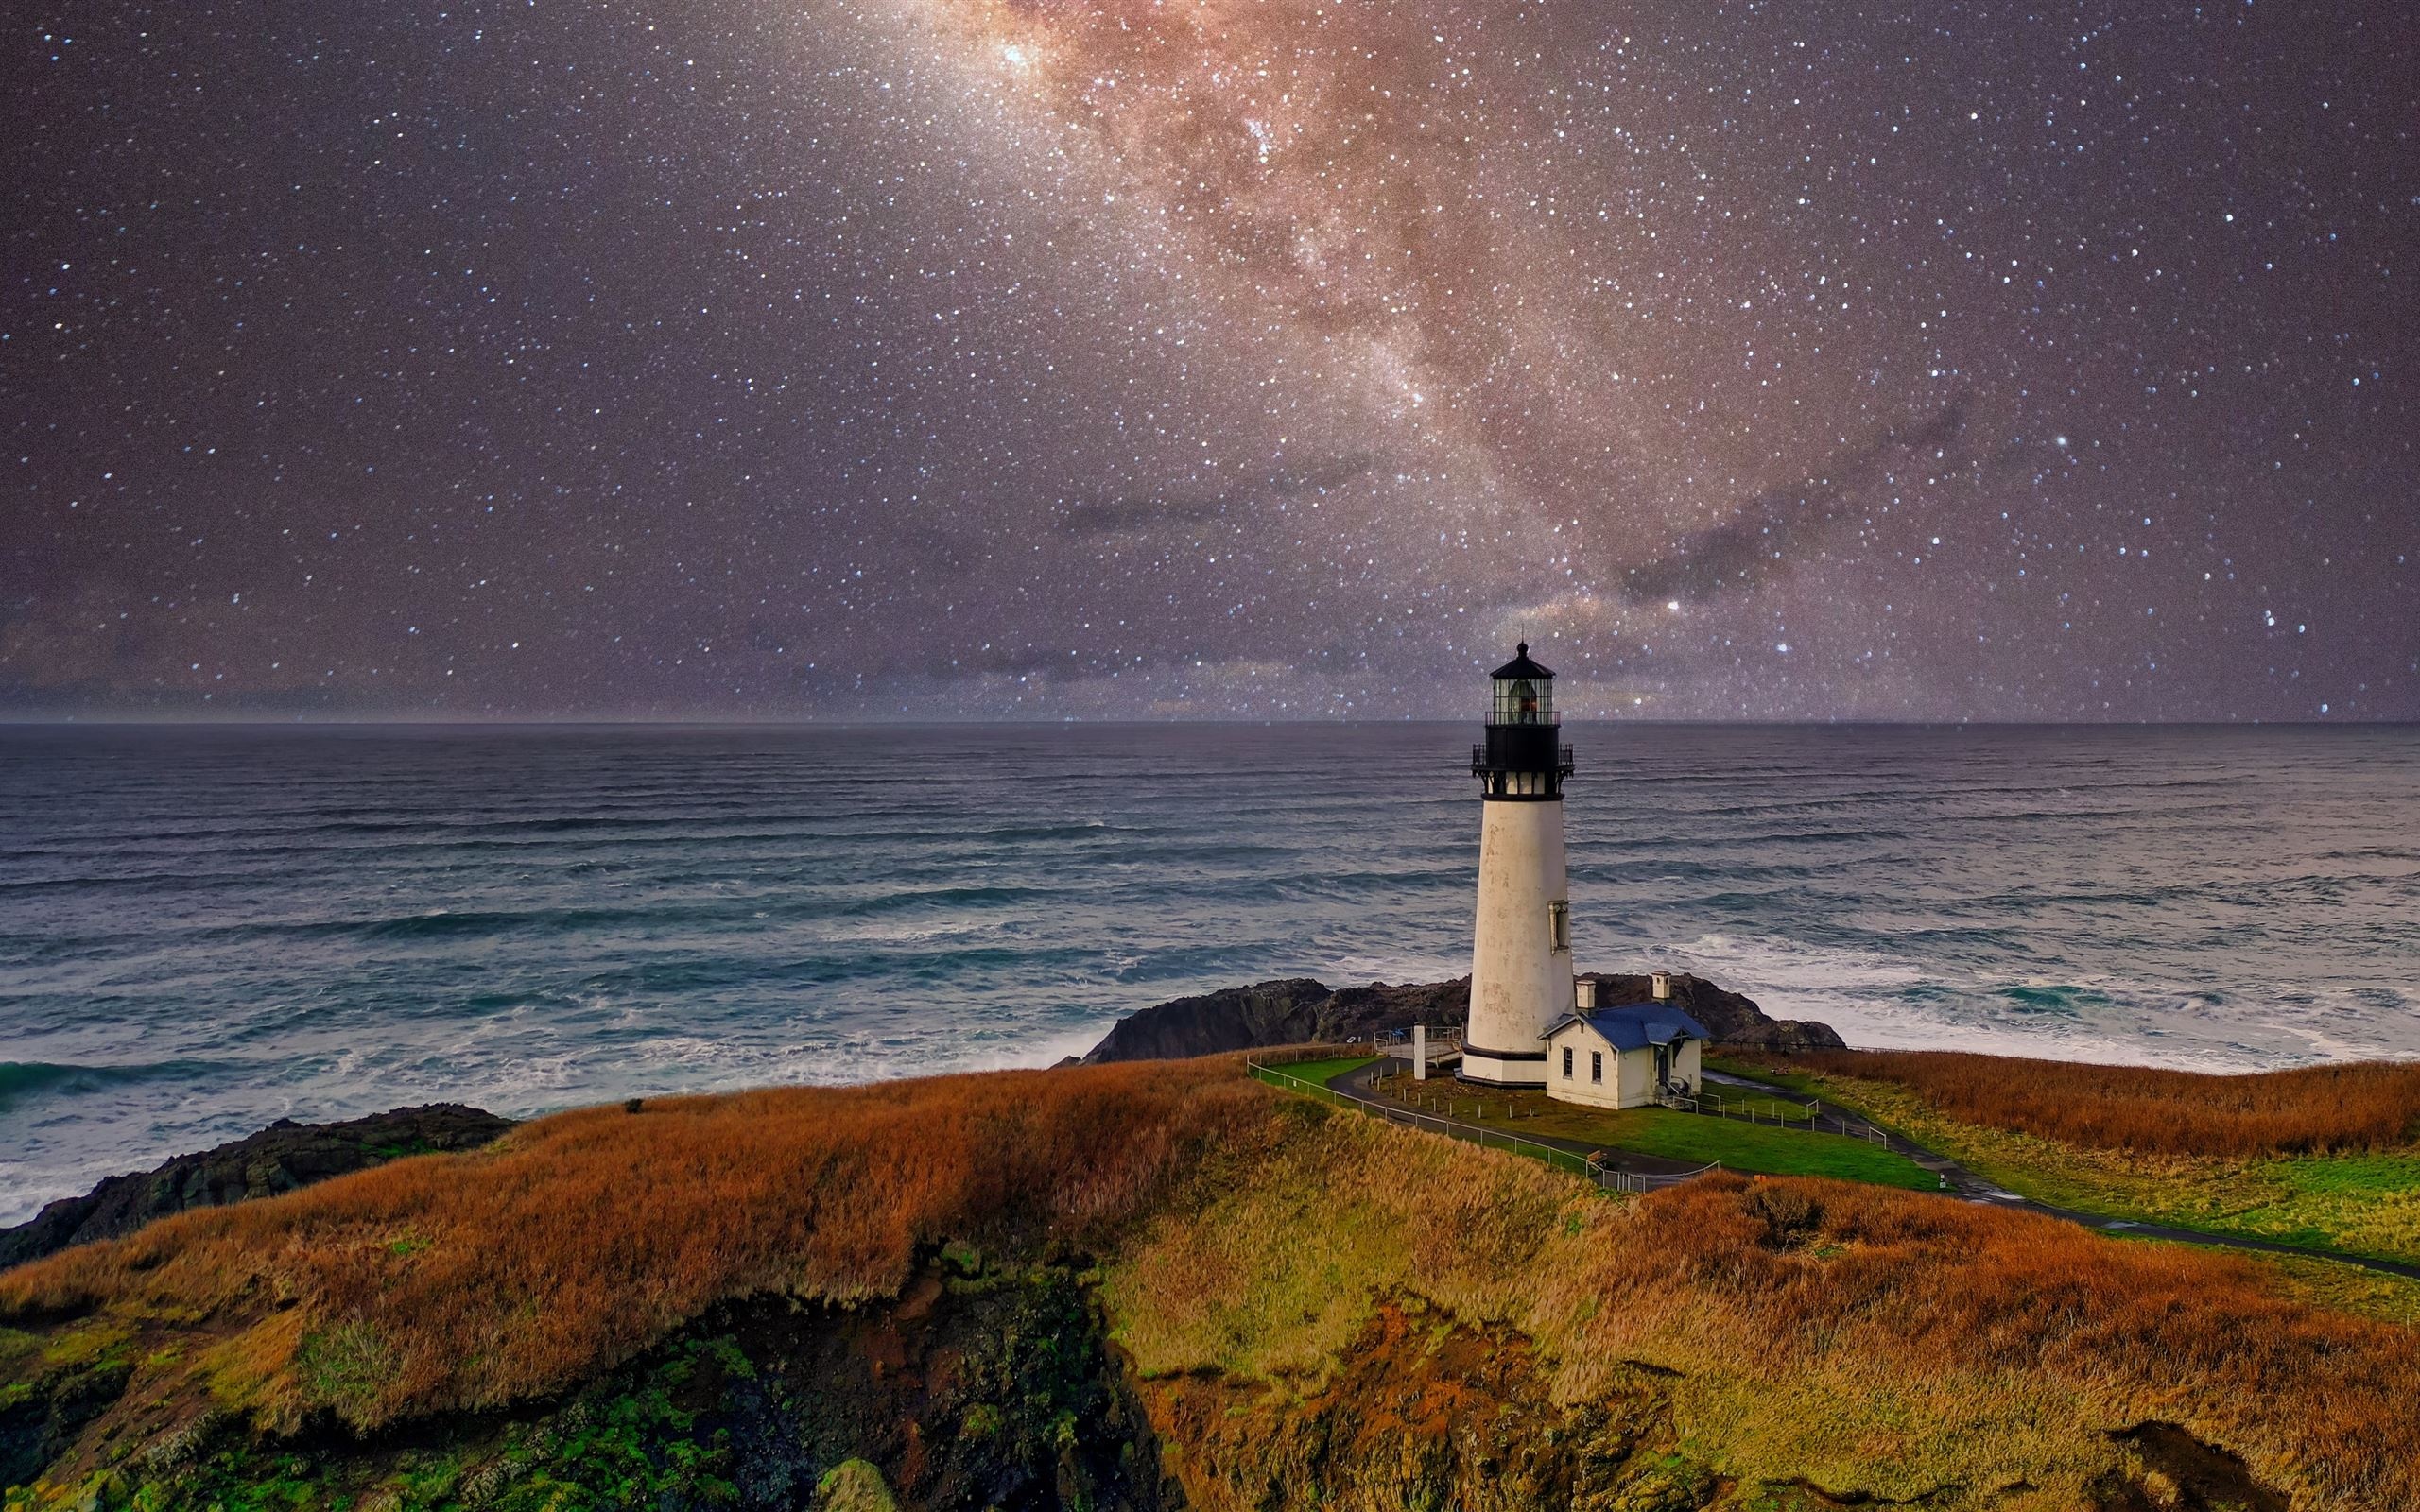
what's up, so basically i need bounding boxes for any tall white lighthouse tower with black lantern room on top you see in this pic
[1461,641,1573,1086]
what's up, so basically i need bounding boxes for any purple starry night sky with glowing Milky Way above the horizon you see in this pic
[0,0,2420,718]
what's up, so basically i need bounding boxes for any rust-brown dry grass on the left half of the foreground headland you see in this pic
[0,1062,1268,1427]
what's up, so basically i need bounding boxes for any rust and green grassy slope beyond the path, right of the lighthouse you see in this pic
[1723,1050,2420,1261]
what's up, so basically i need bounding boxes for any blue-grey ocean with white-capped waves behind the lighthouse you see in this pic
[0,723,2420,1222]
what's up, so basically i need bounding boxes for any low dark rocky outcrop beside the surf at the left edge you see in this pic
[0,1103,513,1270]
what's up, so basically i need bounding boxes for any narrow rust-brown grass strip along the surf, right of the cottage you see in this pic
[1784,1050,2420,1157]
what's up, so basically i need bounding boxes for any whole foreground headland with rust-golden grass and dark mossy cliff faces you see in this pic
[0,1057,2420,1512]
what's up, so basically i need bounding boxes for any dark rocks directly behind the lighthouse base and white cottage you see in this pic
[1084,972,1844,1064]
